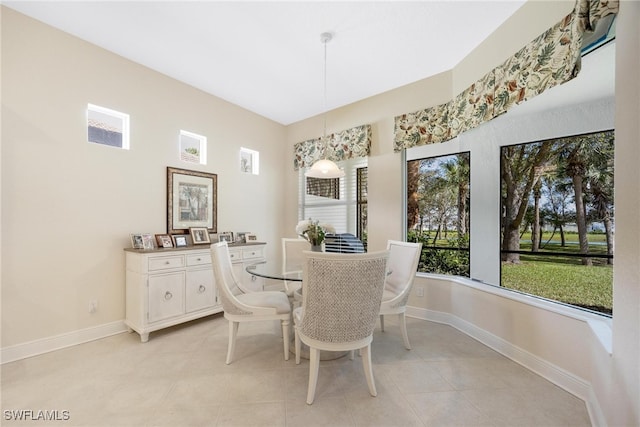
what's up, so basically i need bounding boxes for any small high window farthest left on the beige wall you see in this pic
[87,104,129,150]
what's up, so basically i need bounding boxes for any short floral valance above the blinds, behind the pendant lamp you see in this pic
[293,125,371,170]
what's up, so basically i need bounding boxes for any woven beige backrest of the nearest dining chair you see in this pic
[300,251,389,343]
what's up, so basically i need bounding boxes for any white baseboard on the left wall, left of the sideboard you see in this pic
[0,320,127,364]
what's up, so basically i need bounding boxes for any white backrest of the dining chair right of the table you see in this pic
[384,240,422,298]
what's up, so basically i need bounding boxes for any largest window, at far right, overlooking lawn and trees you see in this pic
[500,131,614,315]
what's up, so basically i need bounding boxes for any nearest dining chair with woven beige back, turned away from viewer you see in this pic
[293,251,388,405]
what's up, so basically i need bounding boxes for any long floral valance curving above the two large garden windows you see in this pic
[394,0,618,152]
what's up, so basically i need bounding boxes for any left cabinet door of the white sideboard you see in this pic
[149,271,184,323]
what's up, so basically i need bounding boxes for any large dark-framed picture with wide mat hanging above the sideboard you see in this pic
[167,167,218,234]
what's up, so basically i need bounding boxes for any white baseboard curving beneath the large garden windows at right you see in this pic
[407,306,606,426]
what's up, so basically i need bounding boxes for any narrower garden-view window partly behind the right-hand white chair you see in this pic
[407,152,471,277]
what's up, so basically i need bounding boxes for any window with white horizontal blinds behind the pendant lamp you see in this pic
[298,157,367,247]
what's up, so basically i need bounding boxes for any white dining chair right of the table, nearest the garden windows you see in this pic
[380,240,422,350]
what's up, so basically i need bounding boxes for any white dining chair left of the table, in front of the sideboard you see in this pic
[211,242,291,365]
